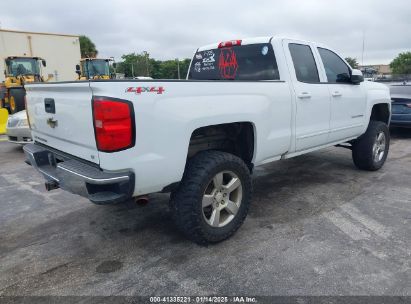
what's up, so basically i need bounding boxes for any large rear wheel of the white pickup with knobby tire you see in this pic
[170,151,252,244]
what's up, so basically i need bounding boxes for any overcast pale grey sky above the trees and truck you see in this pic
[0,0,411,64]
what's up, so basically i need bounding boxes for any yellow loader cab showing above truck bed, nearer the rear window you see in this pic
[76,58,116,80]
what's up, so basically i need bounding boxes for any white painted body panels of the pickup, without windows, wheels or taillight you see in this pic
[27,37,391,204]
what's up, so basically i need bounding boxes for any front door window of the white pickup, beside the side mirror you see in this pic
[318,48,350,82]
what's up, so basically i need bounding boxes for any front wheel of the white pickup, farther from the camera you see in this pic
[352,120,390,171]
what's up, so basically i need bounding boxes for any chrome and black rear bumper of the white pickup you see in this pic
[24,144,134,204]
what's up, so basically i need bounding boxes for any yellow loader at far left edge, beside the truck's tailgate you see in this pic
[0,56,51,134]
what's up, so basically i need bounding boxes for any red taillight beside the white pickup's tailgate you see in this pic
[93,97,134,152]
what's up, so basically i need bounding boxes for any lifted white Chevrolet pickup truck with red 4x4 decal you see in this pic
[24,37,391,244]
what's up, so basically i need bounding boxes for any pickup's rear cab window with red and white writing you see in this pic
[188,43,280,80]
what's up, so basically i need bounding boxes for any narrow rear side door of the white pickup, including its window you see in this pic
[283,40,330,151]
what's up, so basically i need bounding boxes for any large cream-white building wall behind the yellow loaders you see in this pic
[0,29,81,82]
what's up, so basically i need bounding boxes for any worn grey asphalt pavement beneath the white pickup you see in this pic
[0,130,411,296]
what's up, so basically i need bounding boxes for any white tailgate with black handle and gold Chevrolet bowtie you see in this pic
[26,82,99,164]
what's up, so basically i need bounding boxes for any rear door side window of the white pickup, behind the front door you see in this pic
[288,43,320,82]
